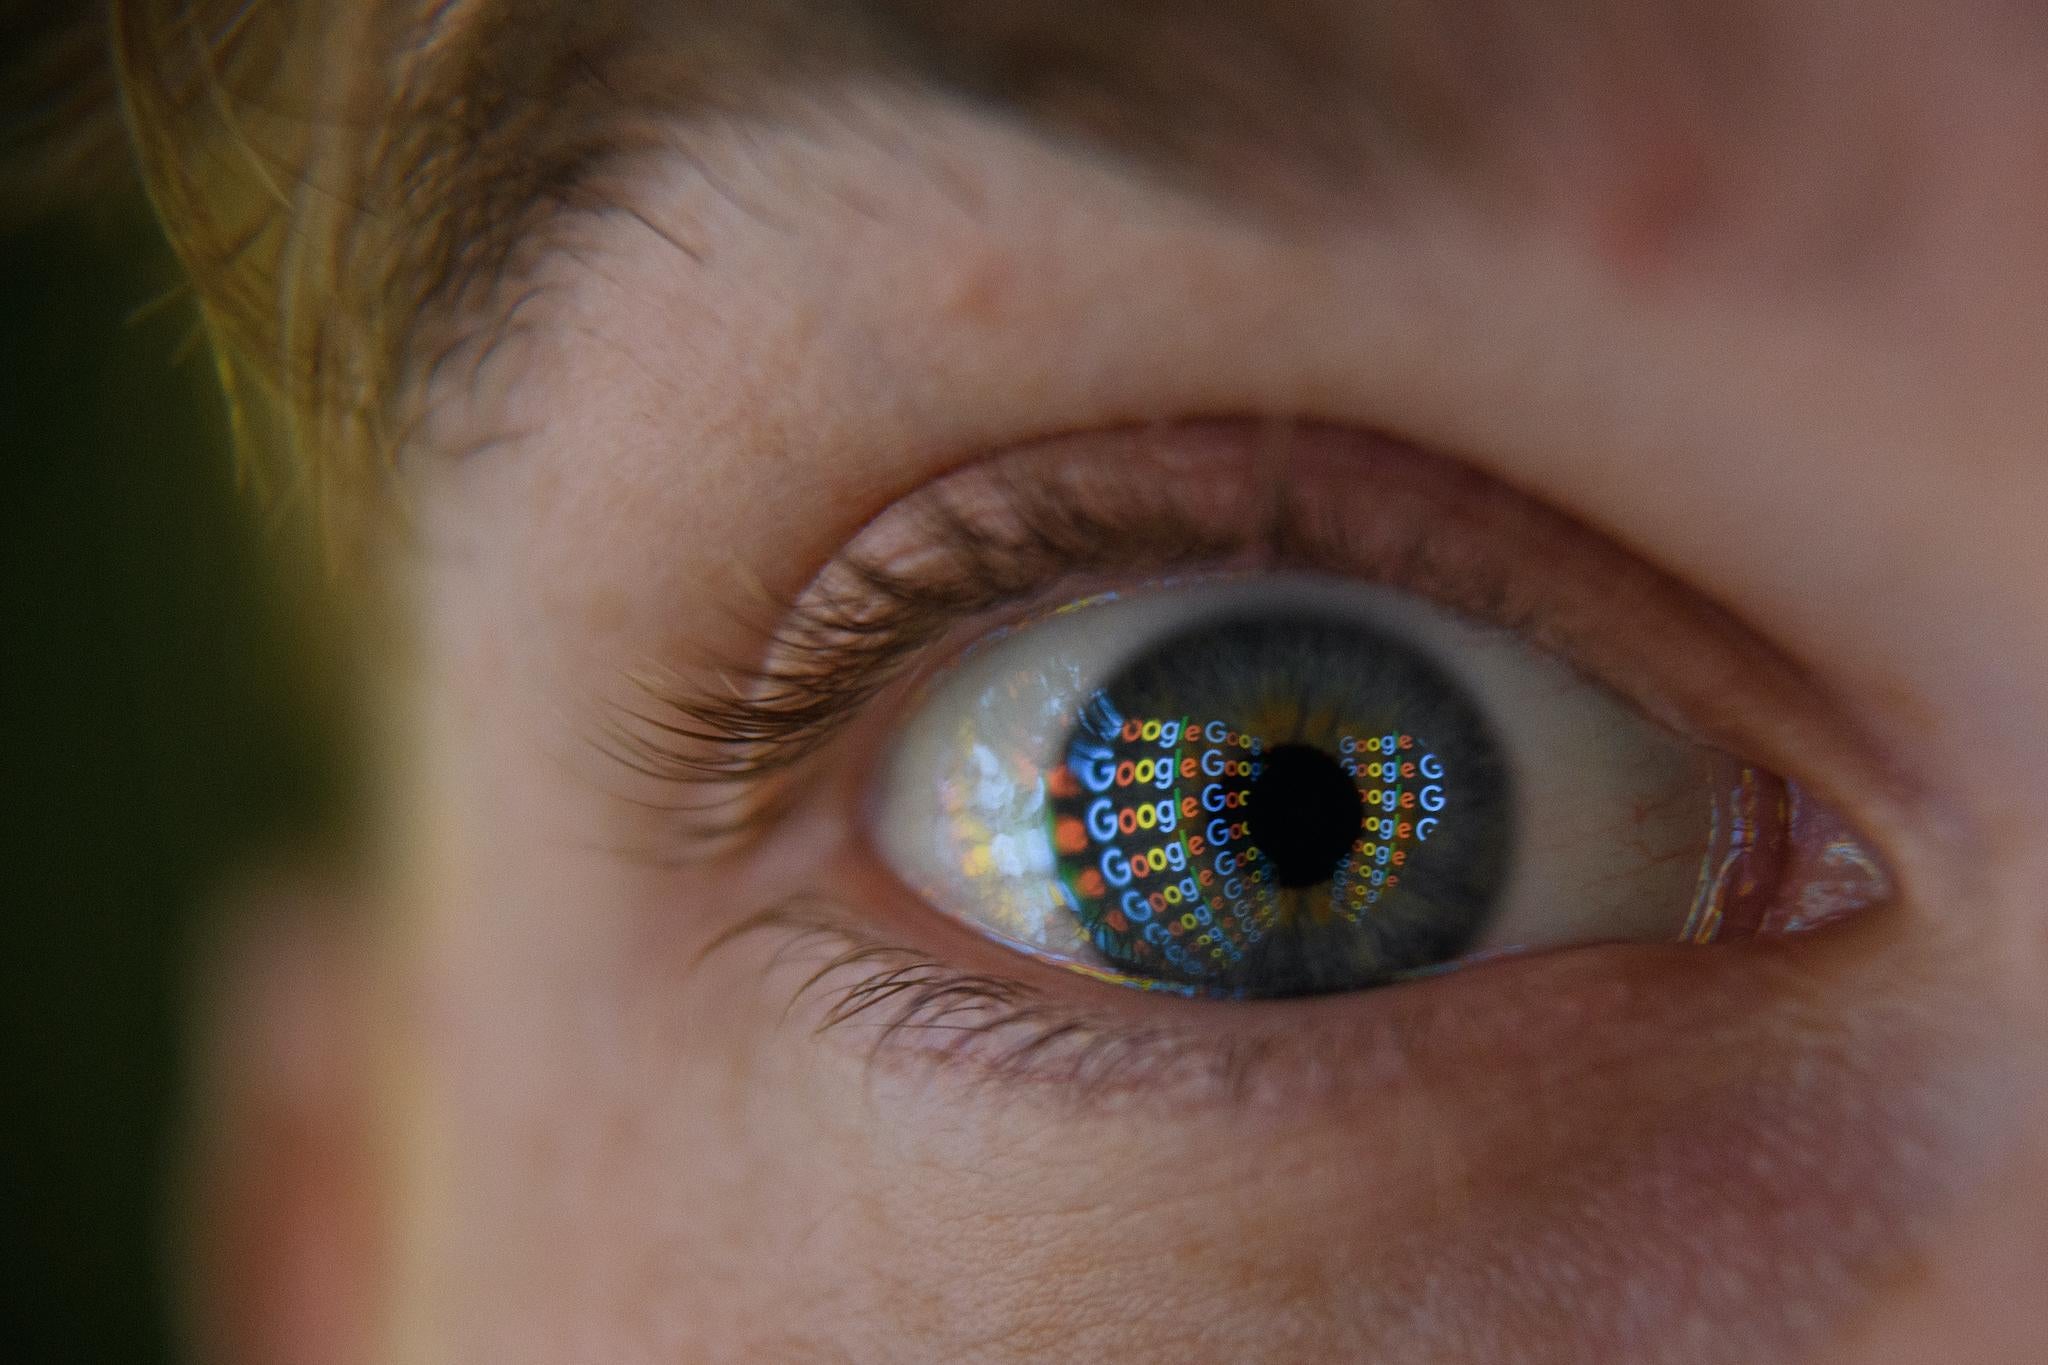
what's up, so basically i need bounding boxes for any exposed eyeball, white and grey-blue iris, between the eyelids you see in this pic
[877,575,1859,997]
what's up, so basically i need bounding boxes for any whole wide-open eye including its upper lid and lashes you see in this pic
[618,424,1890,1060]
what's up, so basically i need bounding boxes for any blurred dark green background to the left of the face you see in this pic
[0,205,332,1365]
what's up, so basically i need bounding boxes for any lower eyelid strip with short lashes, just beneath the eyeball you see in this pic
[698,822,1896,1113]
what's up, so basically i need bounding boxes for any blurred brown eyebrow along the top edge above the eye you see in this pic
[403,0,1769,358]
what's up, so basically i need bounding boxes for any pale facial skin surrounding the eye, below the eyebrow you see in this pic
[180,6,2048,1365]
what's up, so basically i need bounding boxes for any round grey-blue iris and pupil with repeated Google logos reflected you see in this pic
[1047,616,1511,995]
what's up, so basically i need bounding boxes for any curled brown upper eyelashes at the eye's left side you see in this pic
[602,458,1261,837]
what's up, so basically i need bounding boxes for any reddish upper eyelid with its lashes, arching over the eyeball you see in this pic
[600,420,1913,871]
